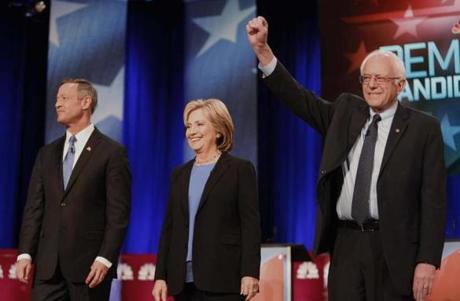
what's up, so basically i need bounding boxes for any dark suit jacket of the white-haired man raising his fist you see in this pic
[264,63,446,294]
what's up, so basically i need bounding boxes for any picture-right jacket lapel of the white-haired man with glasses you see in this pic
[380,103,409,173]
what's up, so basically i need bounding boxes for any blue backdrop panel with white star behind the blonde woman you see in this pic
[184,0,257,166]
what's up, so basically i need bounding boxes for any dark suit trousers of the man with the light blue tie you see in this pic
[32,264,112,301]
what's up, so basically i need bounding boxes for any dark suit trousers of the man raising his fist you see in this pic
[328,228,413,301]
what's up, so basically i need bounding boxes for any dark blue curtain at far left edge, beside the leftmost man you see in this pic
[0,1,48,248]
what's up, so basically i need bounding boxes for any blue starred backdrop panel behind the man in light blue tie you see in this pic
[46,0,127,143]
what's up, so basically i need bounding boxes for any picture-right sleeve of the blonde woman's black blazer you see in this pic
[238,161,261,278]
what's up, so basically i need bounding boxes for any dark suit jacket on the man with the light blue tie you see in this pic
[18,129,131,282]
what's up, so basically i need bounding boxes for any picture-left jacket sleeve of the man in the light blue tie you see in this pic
[18,148,45,259]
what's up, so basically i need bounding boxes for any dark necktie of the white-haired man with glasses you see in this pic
[351,114,382,224]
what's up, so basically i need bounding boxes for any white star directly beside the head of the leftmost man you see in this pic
[92,67,125,124]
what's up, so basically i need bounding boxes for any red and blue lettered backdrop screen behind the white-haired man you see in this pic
[321,0,460,238]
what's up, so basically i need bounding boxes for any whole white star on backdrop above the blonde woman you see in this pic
[192,0,256,57]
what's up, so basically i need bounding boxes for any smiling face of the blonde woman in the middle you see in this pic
[185,109,217,153]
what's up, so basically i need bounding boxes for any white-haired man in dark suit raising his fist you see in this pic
[246,17,446,300]
